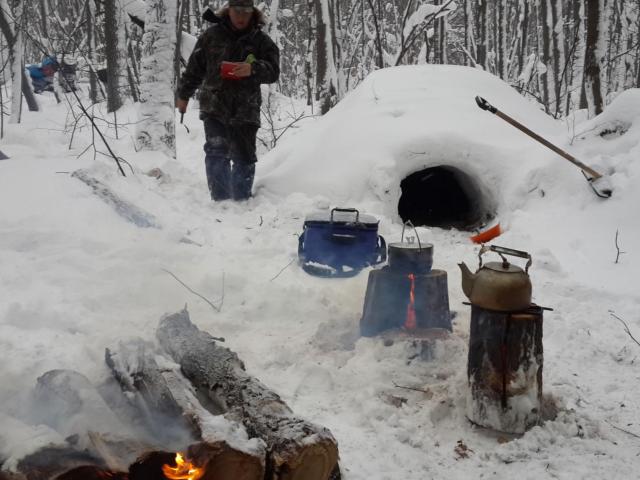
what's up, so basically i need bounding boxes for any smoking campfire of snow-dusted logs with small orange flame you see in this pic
[0,310,340,480]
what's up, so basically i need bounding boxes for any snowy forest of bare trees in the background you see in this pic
[0,0,640,138]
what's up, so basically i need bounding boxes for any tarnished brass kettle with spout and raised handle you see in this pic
[458,245,531,312]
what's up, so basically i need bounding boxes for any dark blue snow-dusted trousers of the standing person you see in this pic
[204,118,258,201]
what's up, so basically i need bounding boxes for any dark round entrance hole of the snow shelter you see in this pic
[398,165,495,231]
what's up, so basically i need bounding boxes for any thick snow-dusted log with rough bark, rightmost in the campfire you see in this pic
[156,309,338,480]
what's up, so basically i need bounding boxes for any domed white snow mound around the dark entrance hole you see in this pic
[258,65,562,220]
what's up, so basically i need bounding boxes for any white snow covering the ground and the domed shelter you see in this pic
[0,66,640,480]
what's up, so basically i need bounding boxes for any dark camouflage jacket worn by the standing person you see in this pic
[177,9,280,125]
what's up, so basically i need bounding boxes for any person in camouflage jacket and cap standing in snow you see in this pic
[176,0,280,201]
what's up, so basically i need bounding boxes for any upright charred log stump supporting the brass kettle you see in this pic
[467,305,543,433]
